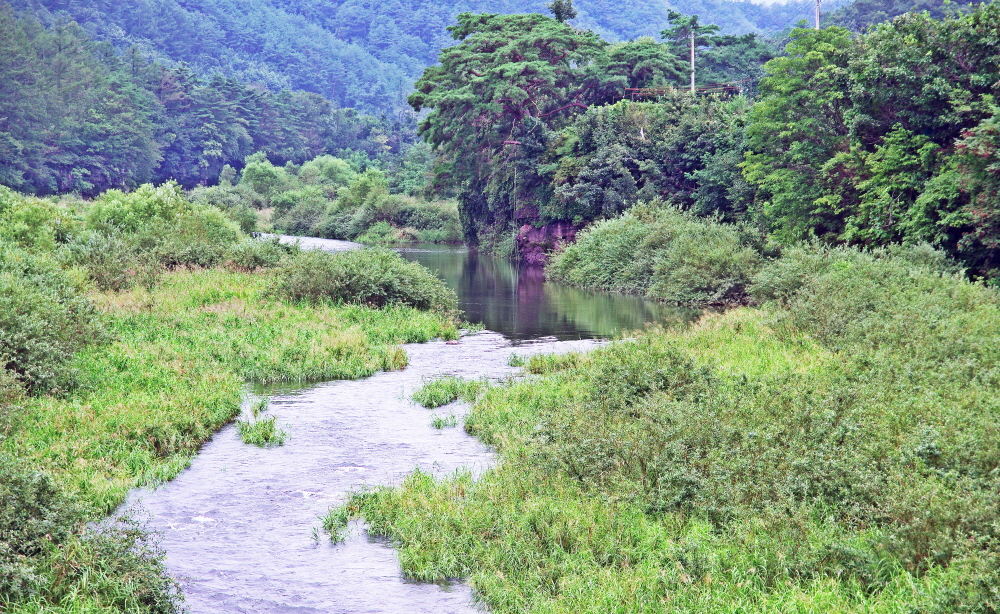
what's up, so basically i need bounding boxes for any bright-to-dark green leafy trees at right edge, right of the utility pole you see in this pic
[744,4,1000,277]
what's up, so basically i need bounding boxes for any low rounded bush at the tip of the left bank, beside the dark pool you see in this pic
[274,249,458,312]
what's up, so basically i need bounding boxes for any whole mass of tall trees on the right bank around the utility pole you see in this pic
[410,4,1000,277]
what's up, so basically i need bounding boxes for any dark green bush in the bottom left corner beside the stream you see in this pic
[0,455,181,614]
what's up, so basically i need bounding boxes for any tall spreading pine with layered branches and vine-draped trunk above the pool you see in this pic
[408,13,678,244]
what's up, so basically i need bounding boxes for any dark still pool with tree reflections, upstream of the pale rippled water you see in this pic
[398,245,701,342]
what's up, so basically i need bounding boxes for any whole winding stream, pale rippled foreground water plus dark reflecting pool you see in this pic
[126,239,691,614]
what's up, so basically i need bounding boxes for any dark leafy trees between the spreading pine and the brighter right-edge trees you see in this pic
[539,98,753,223]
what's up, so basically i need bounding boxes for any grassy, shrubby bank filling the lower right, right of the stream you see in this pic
[328,248,1000,613]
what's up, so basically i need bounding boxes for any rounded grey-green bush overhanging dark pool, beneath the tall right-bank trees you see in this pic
[546,205,760,304]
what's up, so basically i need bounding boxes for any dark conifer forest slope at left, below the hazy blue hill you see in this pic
[0,6,413,195]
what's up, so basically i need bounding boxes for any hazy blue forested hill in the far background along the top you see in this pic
[9,0,830,111]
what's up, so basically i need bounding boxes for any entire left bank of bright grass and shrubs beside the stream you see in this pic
[0,184,457,613]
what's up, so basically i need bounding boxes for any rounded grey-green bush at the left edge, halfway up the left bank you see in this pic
[0,243,101,392]
